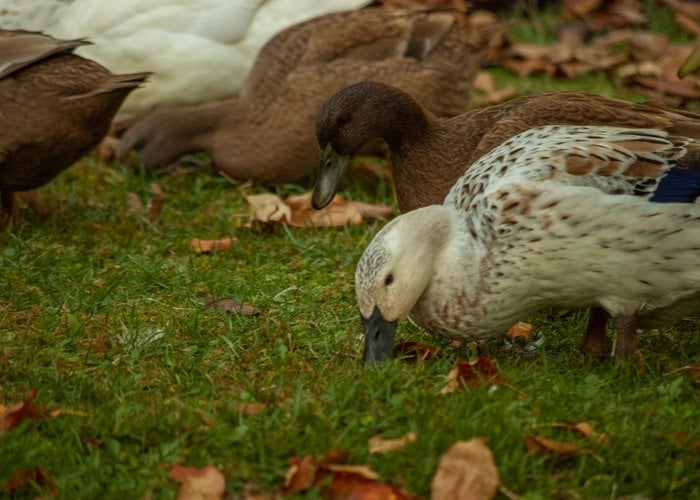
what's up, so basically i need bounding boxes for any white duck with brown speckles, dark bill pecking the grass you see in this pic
[355,125,700,362]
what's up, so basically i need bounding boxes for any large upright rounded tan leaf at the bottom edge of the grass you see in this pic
[430,437,500,500]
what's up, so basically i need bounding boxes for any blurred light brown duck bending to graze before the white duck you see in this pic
[117,9,503,185]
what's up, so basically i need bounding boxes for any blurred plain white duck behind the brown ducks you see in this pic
[0,0,369,123]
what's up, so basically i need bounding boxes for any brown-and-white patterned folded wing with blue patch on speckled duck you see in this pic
[448,125,700,213]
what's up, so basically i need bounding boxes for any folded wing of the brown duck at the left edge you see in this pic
[0,30,89,79]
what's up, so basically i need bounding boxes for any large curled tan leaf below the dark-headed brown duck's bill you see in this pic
[246,192,393,227]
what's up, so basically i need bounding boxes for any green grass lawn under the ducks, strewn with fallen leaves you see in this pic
[0,2,700,499]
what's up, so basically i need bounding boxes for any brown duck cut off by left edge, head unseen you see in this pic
[0,30,148,226]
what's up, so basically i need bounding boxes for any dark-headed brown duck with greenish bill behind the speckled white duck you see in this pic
[313,82,700,358]
